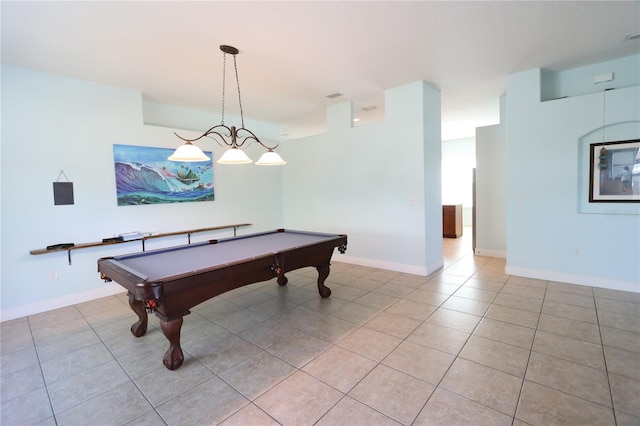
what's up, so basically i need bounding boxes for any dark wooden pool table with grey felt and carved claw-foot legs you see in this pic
[98,229,347,370]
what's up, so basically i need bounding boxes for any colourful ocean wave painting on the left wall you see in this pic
[113,144,215,206]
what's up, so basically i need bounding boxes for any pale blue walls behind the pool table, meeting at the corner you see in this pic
[0,66,442,320]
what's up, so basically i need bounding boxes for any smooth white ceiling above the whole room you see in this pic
[1,0,640,140]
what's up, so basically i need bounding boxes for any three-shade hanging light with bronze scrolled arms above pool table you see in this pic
[168,45,287,166]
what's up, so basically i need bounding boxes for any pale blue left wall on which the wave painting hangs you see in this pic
[0,66,283,320]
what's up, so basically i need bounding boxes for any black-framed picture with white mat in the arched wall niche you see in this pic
[589,139,640,203]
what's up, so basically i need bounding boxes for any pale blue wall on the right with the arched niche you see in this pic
[506,56,640,292]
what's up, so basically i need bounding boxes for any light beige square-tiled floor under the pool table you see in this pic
[0,230,640,426]
